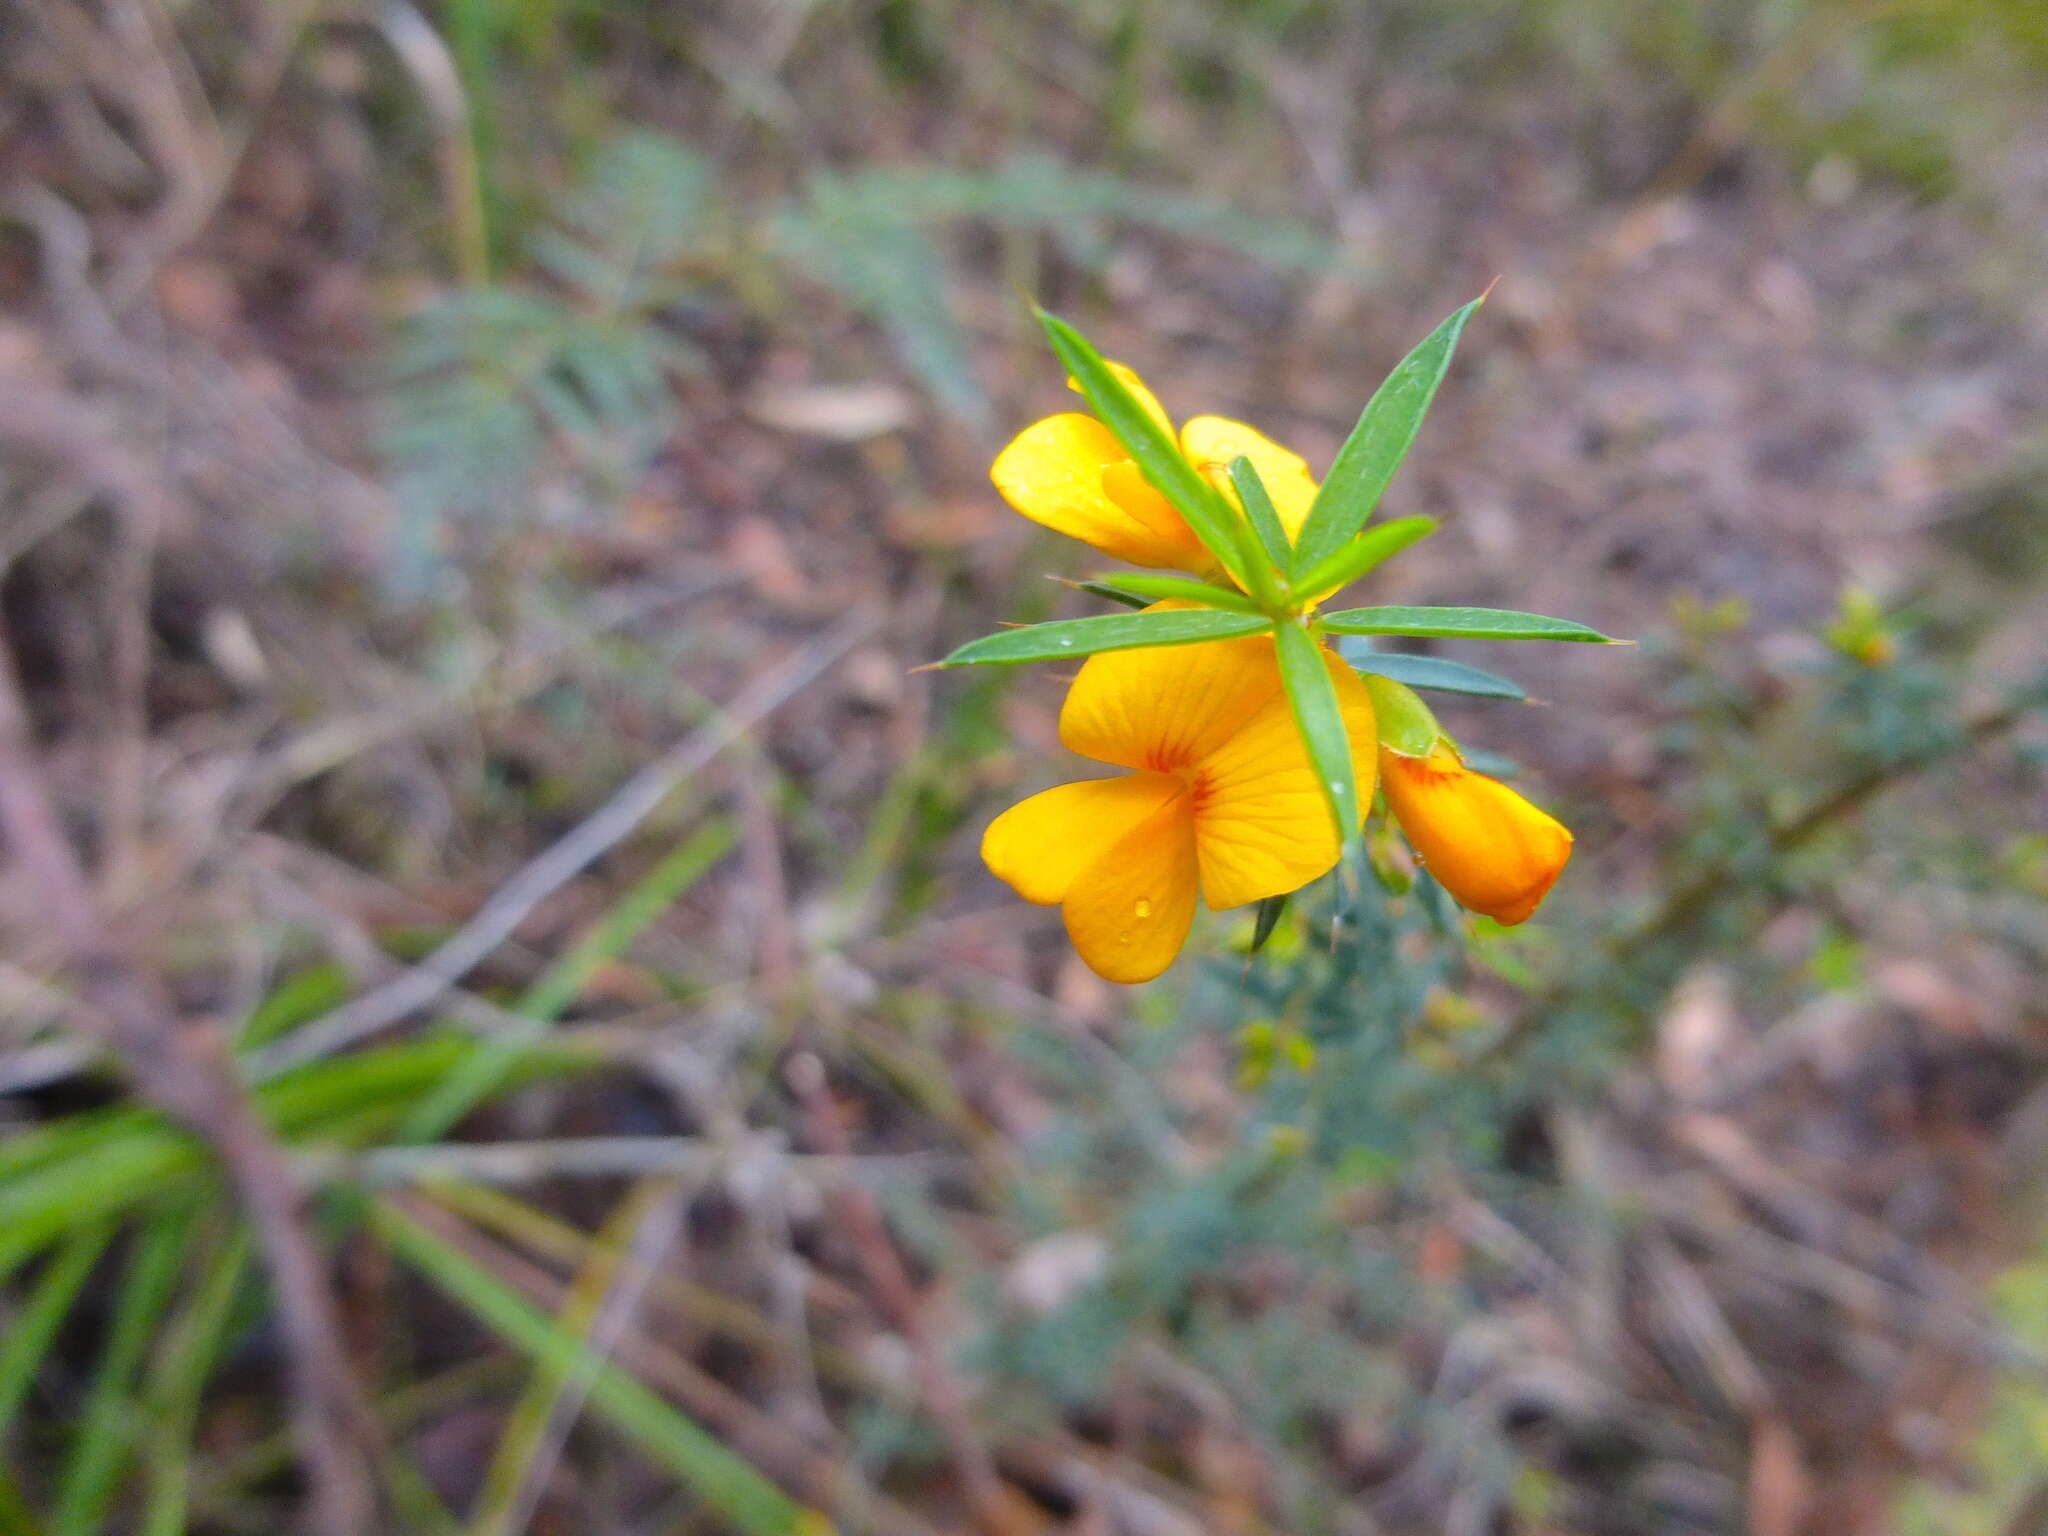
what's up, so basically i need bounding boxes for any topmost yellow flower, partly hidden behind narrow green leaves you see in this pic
[989,362,1315,578]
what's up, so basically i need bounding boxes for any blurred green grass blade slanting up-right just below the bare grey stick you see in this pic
[397,819,737,1143]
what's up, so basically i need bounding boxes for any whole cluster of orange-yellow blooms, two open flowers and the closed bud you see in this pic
[981,369,1571,983]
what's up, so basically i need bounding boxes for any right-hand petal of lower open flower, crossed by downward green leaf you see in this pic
[1194,655,1376,911]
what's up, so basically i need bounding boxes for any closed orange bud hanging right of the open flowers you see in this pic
[1380,745,1571,926]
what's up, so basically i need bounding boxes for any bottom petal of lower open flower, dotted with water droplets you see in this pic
[1061,795,1198,983]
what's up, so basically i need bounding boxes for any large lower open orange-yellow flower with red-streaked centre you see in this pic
[981,635,1376,983]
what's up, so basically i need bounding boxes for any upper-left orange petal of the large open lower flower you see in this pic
[1059,602,1280,772]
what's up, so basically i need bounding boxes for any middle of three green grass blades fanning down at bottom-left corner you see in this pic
[51,1204,197,1536]
